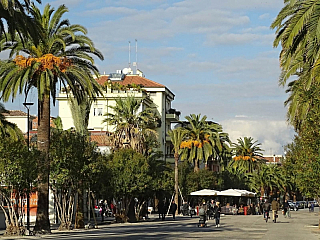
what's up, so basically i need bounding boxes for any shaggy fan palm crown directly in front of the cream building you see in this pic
[102,96,157,155]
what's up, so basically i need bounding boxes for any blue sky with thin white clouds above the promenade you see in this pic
[1,0,293,155]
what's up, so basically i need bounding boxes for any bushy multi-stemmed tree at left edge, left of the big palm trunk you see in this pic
[0,138,42,235]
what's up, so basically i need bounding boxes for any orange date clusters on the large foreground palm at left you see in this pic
[13,54,72,72]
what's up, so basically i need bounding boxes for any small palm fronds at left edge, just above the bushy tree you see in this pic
[0,103,23,140]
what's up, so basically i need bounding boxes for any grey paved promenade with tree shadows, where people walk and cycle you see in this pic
[0,208,320,240]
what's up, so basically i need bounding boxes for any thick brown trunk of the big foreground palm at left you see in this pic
[34,91,50,233]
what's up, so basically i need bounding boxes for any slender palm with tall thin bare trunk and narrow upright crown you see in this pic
[168,127,187,213]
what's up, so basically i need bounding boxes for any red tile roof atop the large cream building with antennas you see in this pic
[97,75,165,88]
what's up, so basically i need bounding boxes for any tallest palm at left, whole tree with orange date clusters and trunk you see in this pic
[0,4,103,232]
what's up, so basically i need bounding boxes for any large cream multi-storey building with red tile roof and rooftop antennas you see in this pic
[57,68,180,159]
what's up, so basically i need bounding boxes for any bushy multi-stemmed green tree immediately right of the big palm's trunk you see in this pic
[50,129,102,230]
